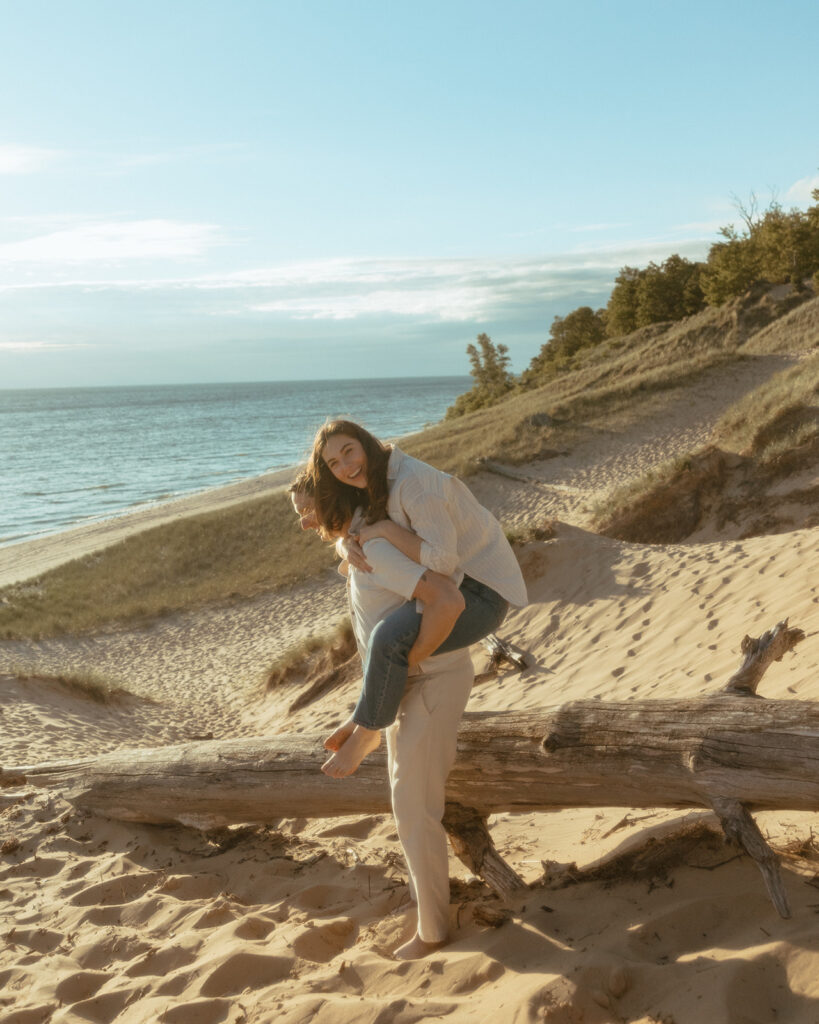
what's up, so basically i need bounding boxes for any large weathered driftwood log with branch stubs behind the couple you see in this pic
[0,622,806,916]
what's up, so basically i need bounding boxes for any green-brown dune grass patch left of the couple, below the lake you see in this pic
[0,492,334,638]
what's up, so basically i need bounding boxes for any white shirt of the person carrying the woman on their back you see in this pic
[347,537,472,675]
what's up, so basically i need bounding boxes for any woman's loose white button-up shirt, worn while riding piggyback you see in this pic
[387,447,528,607]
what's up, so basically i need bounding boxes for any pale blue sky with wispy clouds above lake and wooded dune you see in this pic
[0,0,819,388]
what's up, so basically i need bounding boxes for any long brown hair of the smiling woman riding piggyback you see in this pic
[307,420,391,535]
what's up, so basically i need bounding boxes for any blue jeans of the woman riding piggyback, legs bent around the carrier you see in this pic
[352,577,509,729]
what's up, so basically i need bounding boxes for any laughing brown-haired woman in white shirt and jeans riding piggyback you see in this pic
[308,420,527,770]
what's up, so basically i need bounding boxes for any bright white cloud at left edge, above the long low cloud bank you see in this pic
[0,219,219,265]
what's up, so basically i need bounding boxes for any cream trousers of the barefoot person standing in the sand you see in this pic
[387,650,474,942]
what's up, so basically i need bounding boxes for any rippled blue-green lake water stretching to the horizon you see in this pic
[0,377,472,545]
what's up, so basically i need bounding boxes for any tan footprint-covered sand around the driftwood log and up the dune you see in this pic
[0,362,819,1024]
